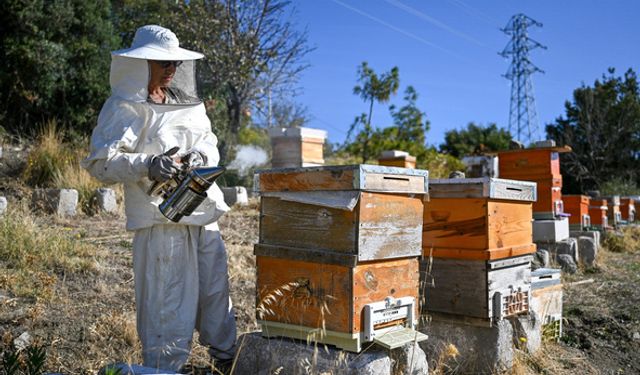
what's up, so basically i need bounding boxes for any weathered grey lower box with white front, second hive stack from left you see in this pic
[421,255,533,325]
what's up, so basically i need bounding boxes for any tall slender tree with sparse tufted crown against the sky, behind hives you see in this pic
[347,61,400,163]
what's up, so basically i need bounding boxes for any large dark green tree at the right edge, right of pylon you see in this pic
[546,68,640,193]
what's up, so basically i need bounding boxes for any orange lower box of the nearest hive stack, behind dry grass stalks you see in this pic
[256,253,419,352]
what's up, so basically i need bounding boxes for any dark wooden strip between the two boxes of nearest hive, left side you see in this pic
[253,244,358,267]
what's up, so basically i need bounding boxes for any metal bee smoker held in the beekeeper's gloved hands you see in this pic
[149,167,226,223]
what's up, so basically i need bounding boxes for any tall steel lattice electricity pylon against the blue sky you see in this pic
[500,13,547,143]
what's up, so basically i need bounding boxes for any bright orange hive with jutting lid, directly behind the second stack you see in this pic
[498,146,571,219]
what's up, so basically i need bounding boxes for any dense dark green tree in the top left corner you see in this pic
[0,0,119,135]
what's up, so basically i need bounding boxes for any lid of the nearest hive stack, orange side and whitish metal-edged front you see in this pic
[253,164,429,194]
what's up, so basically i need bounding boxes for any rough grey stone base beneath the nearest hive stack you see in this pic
[235,332,428,375]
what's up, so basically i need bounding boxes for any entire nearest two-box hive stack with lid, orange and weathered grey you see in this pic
[255,165,428,352]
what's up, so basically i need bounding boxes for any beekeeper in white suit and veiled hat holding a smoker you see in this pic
[83,25,236,370]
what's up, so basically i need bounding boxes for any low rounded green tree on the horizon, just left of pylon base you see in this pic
[440,122,511,158]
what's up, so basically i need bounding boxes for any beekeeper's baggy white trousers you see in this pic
[133,224,236,371]
